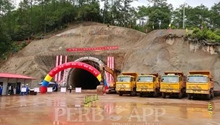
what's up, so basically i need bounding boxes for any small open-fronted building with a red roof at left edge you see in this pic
[0,73,35,95]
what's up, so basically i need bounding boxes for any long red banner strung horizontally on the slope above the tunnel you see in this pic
[66,46,118,52]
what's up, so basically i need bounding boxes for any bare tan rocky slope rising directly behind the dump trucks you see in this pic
[123,37,220,90]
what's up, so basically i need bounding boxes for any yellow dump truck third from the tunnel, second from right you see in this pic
[160,71,186,98]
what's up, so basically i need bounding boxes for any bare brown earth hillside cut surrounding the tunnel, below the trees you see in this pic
[0,23,220,90]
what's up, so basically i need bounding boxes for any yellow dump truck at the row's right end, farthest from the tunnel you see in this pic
[186,71,214,99]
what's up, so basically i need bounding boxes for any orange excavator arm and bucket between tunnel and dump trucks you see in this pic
[103,66,121,93]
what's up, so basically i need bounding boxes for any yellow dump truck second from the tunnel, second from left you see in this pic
[136,73,160,97]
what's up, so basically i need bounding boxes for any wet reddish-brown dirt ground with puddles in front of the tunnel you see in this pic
[0,93,220,125]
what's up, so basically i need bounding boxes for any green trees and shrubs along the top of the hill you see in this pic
[0,0,220,57]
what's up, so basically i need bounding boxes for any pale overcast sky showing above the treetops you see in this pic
[14,0,220,8]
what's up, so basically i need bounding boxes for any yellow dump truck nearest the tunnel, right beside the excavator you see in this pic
[116,73,138,96]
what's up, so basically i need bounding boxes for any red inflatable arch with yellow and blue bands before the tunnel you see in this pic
[40,62,102,93]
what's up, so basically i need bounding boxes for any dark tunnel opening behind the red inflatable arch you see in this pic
[67,60,100,90]
